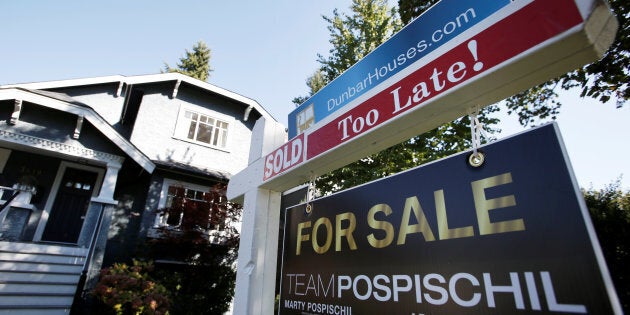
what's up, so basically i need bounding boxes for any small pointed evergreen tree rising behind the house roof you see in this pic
[164,41,213,81]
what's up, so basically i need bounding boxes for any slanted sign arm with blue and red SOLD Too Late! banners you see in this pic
[261,0,617,186]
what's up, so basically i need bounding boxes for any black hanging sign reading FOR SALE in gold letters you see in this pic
[279,124,621,315]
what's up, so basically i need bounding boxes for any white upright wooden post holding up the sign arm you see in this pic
[228,119,286,315]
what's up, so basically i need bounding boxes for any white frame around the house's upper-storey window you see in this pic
[173,104,236,152]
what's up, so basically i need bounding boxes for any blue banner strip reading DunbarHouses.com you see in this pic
[288,0,513,139]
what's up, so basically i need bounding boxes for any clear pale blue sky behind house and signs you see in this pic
[0,0,630,190]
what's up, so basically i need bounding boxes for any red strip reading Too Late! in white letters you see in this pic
[307,0,582,159]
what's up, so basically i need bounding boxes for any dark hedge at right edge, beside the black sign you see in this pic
[583,181,630,313]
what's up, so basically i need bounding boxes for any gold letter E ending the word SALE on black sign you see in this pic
[471,173,525,235]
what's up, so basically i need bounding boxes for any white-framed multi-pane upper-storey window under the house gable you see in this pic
[178,109,229,149]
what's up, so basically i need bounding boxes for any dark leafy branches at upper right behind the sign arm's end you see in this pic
[398,0,630,126]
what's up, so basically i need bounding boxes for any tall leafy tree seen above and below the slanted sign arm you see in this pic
[294,0,498,193]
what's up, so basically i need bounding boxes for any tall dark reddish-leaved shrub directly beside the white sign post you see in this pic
[150,184,242,314]
